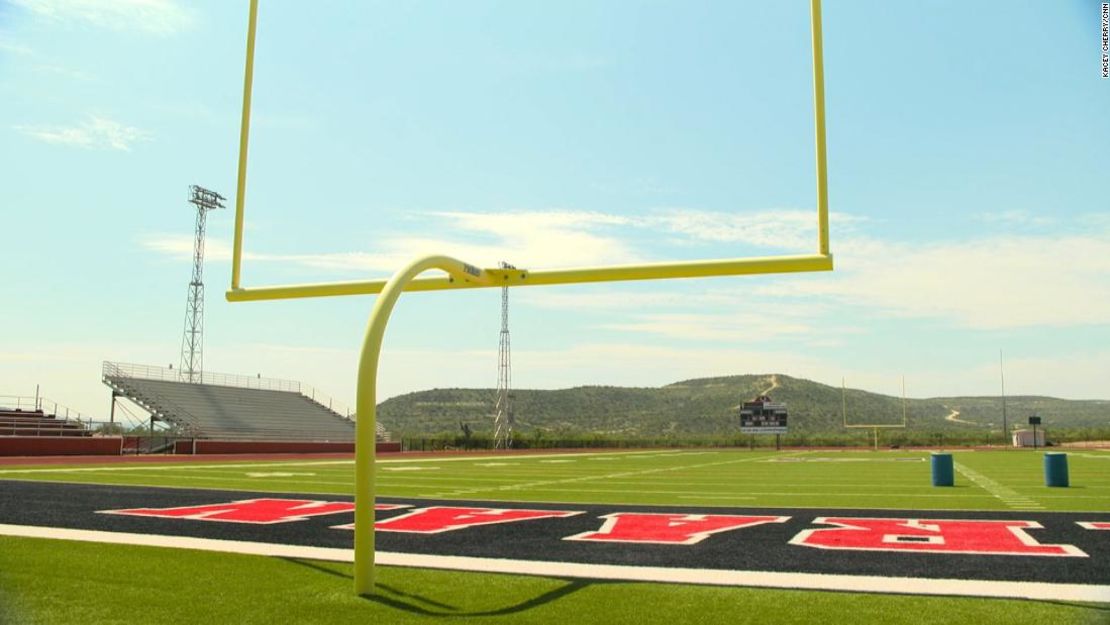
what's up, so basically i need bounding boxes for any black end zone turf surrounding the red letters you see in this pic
[0,481,1110,602]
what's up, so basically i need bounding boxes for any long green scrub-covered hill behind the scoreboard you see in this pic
[377,374,1110,438]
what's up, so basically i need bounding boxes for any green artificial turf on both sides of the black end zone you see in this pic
[0,450,1110,625]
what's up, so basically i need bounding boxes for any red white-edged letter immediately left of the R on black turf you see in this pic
[563,512,790,545]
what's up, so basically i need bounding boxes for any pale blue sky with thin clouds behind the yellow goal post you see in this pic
[0,0,1110,416]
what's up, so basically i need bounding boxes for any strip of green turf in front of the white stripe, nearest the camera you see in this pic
[0,537,1110,625]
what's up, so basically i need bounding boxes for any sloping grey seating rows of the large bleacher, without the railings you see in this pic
[104,373,354,442]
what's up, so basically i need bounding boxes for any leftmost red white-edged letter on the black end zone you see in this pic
[100,500,407,525]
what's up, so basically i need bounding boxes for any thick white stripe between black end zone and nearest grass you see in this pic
[0,524,1110,603]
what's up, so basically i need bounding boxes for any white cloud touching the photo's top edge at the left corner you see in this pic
[11,0,193,34]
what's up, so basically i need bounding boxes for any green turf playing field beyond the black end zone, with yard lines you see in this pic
[0,450,1110,512]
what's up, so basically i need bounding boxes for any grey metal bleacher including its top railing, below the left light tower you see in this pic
[103,362,389,442]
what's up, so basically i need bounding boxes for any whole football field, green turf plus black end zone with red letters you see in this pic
[0,450,1110,624]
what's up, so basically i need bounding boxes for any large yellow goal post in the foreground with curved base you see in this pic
[225,0,833,595]
